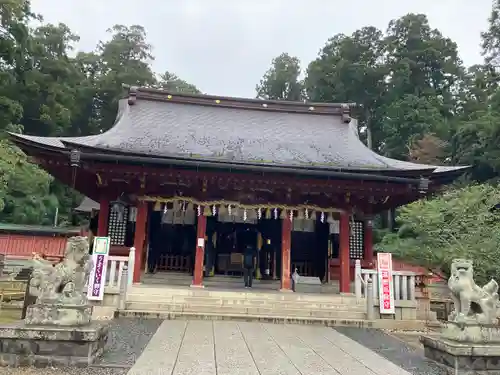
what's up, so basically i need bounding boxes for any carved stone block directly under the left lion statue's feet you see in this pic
[24,305,92,326]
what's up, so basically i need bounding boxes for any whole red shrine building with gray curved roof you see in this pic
[10,87,464,292]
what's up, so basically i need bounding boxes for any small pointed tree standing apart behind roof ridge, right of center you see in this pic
[255,53,304,101]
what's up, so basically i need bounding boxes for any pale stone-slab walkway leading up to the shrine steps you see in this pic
[128,320,411,375]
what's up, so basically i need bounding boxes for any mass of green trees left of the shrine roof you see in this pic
[0,0,199,225]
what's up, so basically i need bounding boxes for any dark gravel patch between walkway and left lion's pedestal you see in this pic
[94,318,163,368]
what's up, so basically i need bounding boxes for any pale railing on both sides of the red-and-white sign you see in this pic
[354,260,426,301]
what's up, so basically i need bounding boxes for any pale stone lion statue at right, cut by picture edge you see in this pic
[448,259,499,324]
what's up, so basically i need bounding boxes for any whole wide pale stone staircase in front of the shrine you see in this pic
[119,284,366,325]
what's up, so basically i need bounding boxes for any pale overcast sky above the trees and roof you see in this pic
[32,0,492,97]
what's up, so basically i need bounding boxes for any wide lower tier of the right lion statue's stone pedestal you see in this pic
[420,336,500,375]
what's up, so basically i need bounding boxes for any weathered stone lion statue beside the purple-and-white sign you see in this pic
[30,237,92,305]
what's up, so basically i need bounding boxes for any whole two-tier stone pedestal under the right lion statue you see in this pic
[420,322,500,375]
